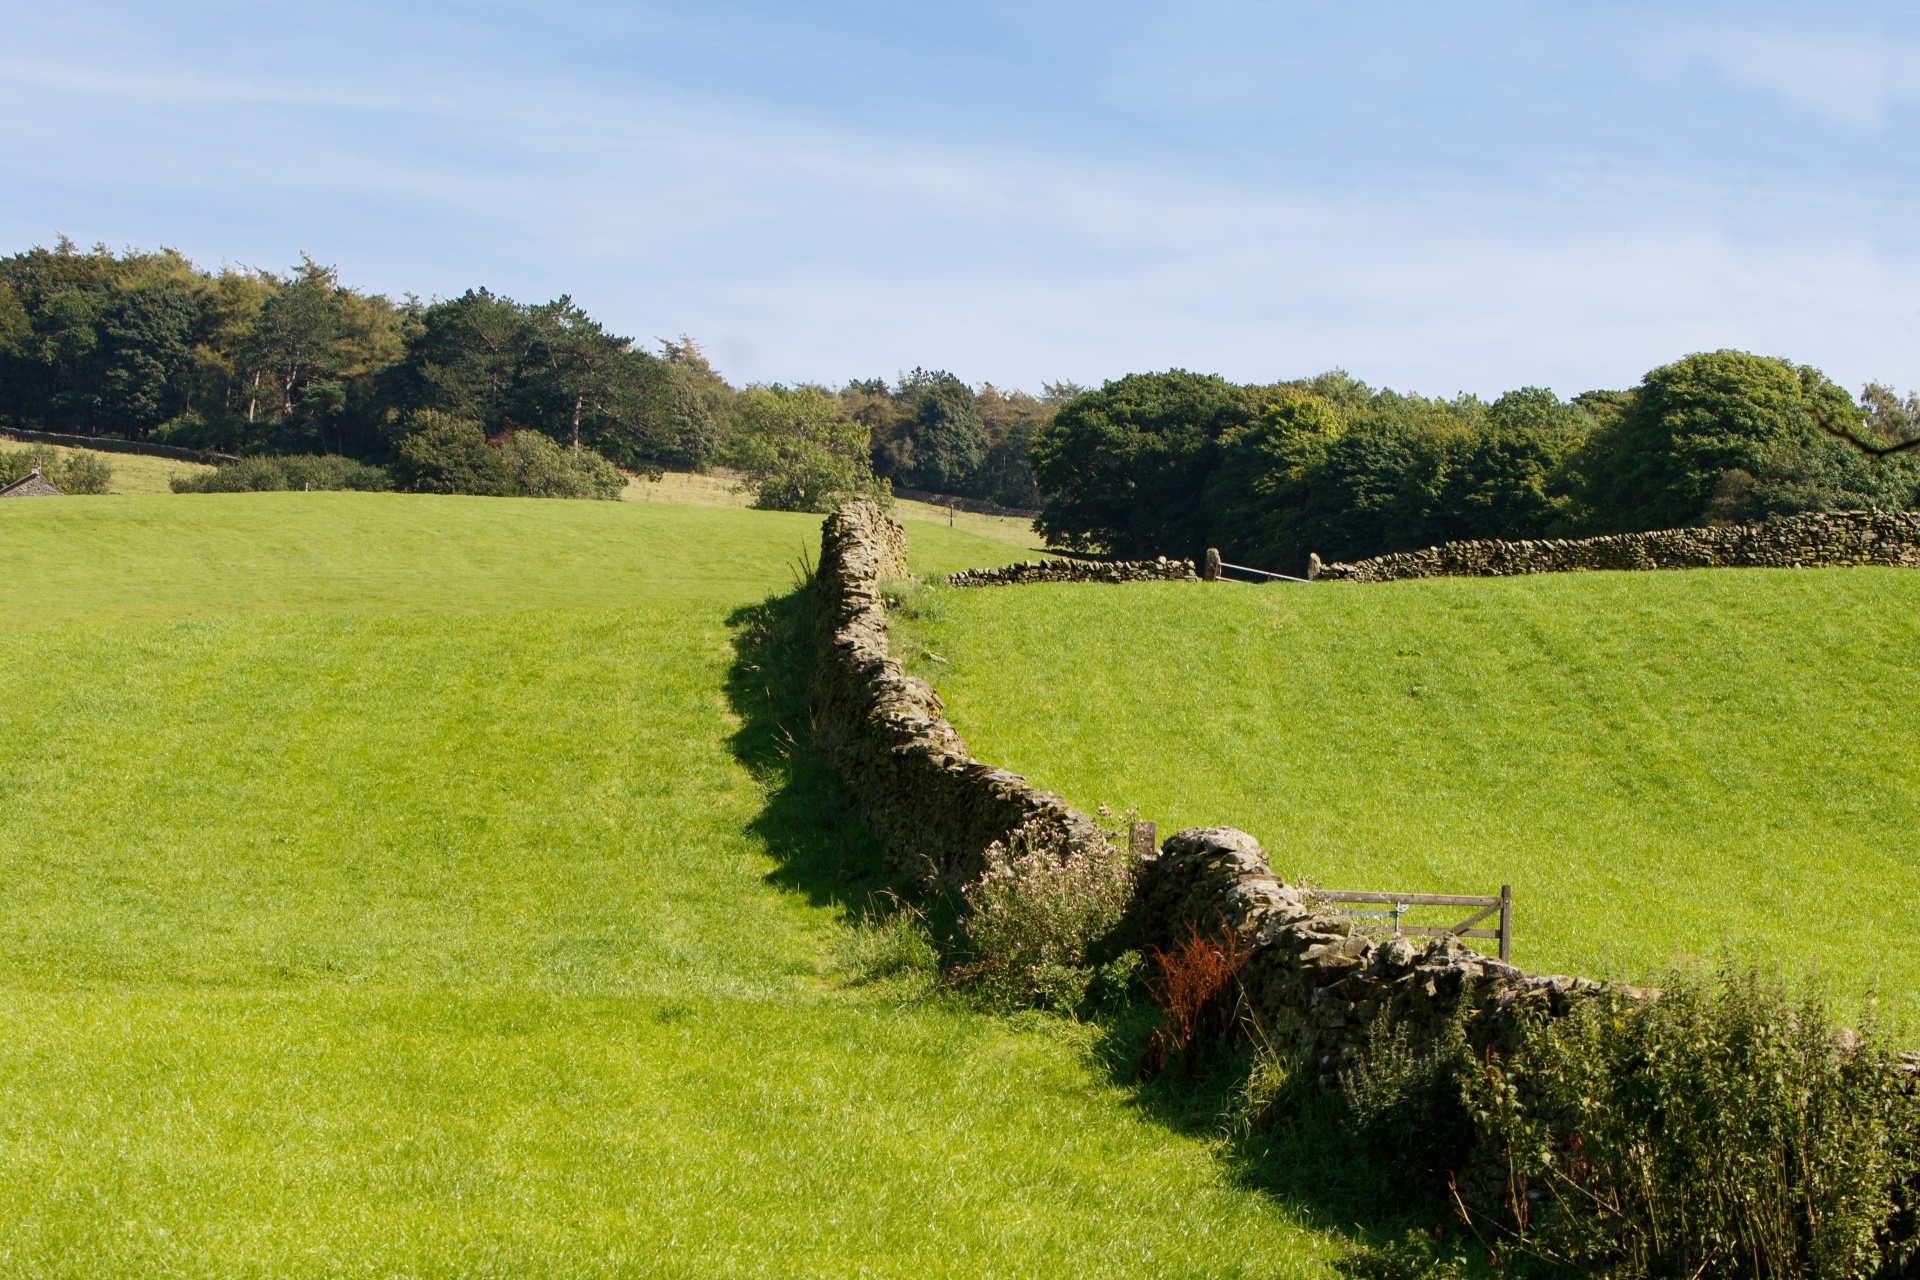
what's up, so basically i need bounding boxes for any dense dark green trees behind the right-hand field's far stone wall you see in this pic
[1033,351,1920,574]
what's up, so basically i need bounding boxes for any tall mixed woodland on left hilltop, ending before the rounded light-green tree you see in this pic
[0,240,733,470]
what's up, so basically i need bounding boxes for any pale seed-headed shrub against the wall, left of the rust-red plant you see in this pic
[950,823,1135,1009]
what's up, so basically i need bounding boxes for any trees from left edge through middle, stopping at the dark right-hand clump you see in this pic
[0,238,1079,509]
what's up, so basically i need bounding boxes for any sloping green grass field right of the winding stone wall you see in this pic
[914,568,1920,1015]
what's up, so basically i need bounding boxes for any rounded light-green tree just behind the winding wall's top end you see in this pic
[728,384,891,510]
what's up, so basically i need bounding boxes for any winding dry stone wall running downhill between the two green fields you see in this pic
[816,501,1599,1079]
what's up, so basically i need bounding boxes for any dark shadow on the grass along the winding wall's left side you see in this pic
[728,574,1466,1274]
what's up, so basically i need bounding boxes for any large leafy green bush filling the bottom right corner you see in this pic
[1463,967,1920,1280]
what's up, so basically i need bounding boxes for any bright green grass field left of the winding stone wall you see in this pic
[0,493,1329,1278]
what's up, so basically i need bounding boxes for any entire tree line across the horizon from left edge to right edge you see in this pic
[0,238,1920,545]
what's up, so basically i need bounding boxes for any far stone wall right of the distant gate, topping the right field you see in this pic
[1315,510,1920,581]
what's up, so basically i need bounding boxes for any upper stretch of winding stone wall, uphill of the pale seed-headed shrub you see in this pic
[816,499,1102,883]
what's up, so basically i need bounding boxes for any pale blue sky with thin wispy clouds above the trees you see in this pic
[0,0,1920,395]
